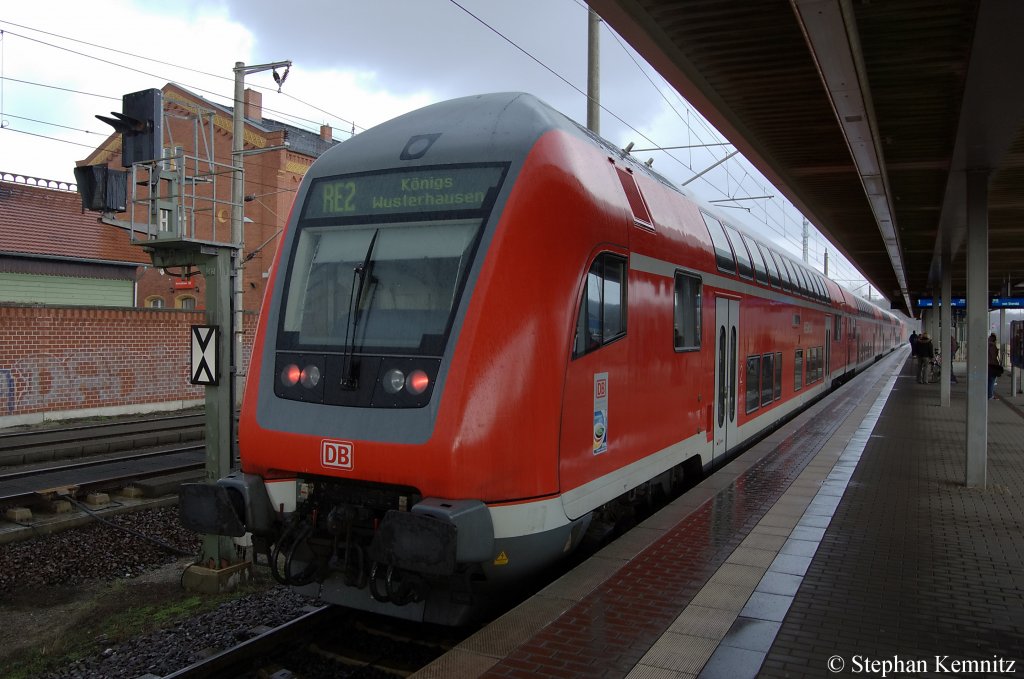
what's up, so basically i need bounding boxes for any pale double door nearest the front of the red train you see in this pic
[714,297,739,461]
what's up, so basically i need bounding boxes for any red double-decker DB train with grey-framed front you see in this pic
[182,93,904,624]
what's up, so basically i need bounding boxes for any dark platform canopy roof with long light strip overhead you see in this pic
[589,0,1024,311]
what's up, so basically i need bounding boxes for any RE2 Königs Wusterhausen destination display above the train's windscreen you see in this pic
[302,165,505,219]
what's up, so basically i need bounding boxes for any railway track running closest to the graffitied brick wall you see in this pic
[0,413,205,468]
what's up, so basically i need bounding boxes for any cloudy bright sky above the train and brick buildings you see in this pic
[0,0,866,293]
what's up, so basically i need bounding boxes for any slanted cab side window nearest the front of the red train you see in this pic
[572,252,626,356]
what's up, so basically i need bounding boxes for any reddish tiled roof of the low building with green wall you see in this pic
[0,173,150,264]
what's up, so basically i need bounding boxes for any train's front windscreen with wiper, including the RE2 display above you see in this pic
[279,166,505,355]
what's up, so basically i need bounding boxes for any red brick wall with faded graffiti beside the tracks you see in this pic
[0,304,256,426]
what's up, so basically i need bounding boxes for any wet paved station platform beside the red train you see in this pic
[414,348,1024,679]
